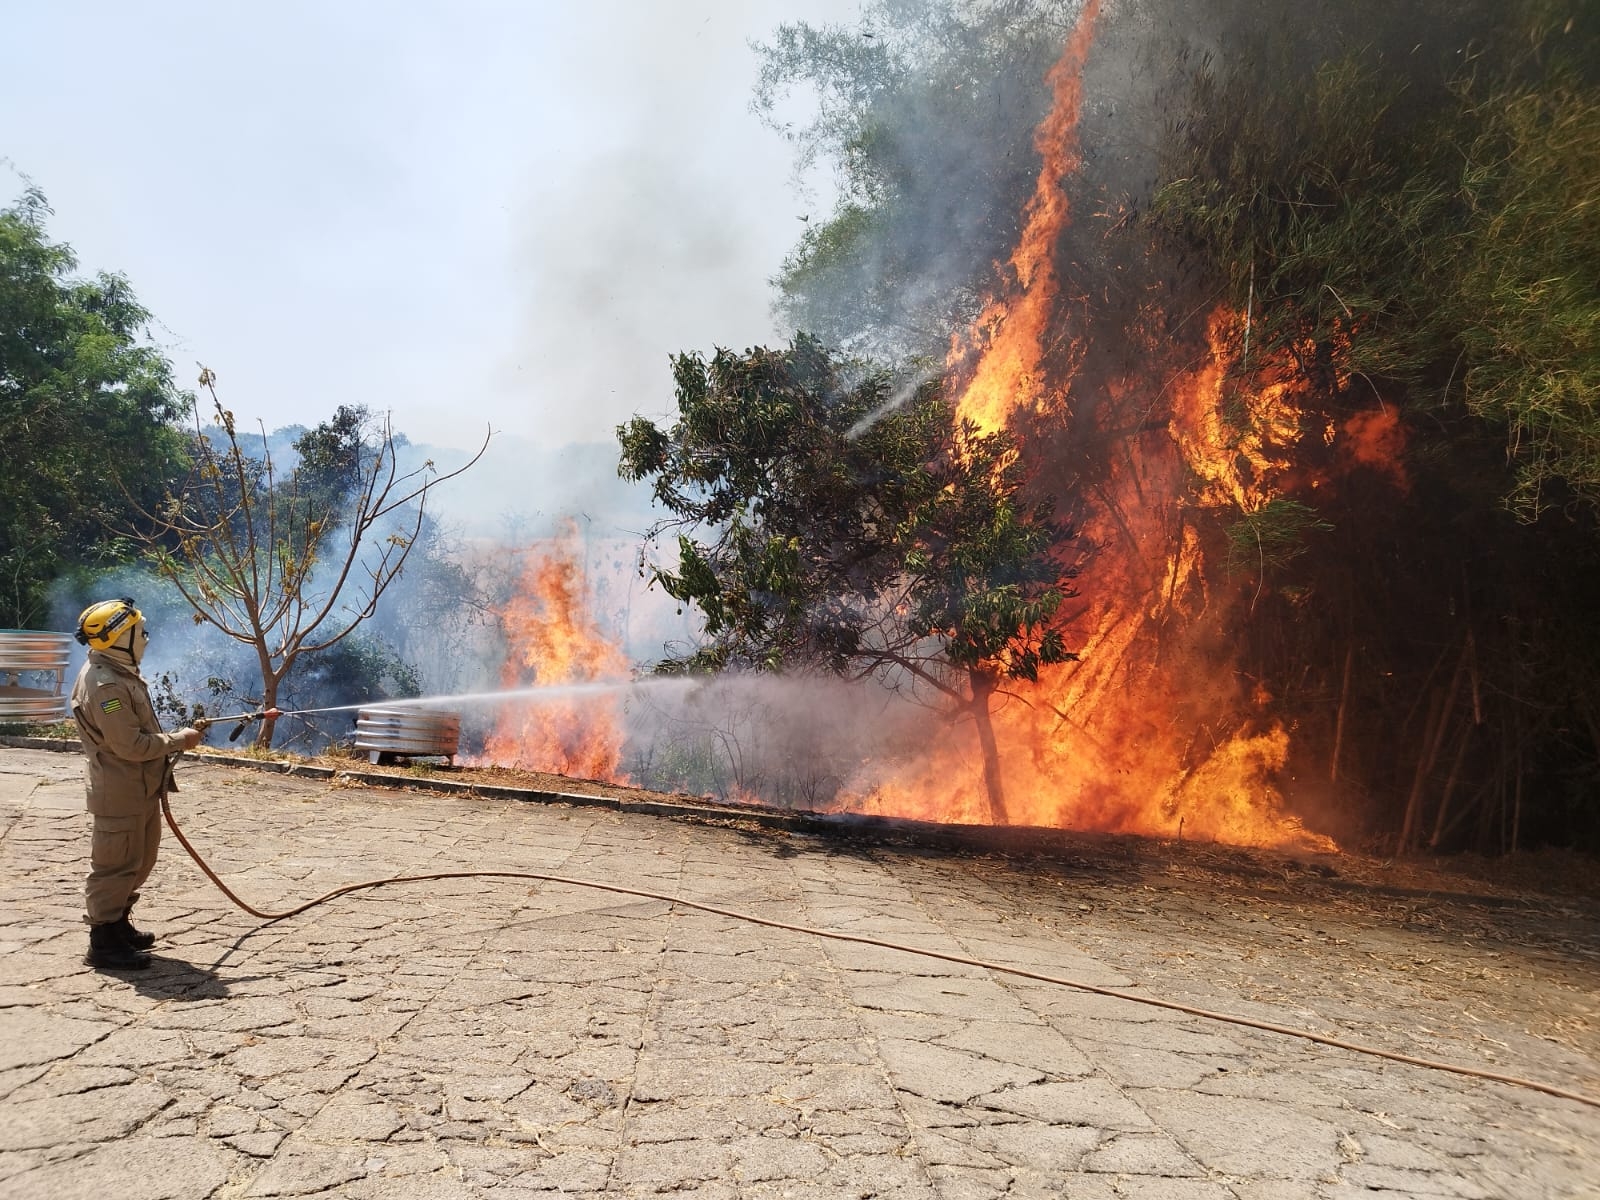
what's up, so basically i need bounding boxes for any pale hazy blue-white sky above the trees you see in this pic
[0,0,859,448]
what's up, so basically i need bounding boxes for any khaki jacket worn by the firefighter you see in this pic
[72,650,184,816]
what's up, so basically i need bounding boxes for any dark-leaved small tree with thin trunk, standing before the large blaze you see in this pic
[618,336,1075,824]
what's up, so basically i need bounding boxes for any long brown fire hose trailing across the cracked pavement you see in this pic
[162,774,1600,1109]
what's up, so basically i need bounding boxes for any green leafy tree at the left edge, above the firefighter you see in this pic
[0,189,192,627]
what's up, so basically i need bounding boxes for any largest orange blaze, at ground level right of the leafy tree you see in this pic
[842,310,1336,851]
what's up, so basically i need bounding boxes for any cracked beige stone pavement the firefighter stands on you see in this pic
[0,749,1600,1200]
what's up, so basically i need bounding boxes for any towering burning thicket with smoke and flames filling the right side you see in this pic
[723,0,1600,848]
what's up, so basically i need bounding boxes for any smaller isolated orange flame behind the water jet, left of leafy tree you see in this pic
[483,528,629,782]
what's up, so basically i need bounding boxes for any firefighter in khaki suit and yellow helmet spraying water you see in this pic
[72,597,200,971]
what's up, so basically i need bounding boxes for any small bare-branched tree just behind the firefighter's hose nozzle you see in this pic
[126,370,488,747]
